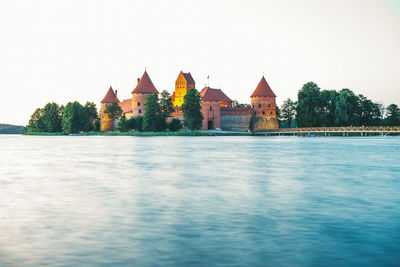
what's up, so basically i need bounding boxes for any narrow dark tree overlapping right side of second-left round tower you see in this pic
[143,94,165,132]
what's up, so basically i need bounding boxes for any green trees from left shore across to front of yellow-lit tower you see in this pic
[24,88,203,134]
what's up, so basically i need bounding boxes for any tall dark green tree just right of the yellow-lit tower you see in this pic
[181,88,203,131]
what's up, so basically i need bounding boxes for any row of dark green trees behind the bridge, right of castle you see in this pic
[277,82,400,127]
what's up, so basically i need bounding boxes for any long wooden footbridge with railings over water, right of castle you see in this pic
[255,126,400,136]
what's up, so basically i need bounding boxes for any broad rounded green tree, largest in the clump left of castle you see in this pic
[62,101,87,134]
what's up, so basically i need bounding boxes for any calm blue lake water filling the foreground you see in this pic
[0,135,400,266]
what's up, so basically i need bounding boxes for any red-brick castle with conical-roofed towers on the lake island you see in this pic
[100,71,279,132]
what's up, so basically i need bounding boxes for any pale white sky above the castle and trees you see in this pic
[0,0,400,125]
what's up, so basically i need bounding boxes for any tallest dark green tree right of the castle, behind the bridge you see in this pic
[296,82,320,127]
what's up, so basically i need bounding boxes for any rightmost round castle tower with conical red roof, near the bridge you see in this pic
[250,76,279,131]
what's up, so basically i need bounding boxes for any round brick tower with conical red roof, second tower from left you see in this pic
[132,71,158,116]
